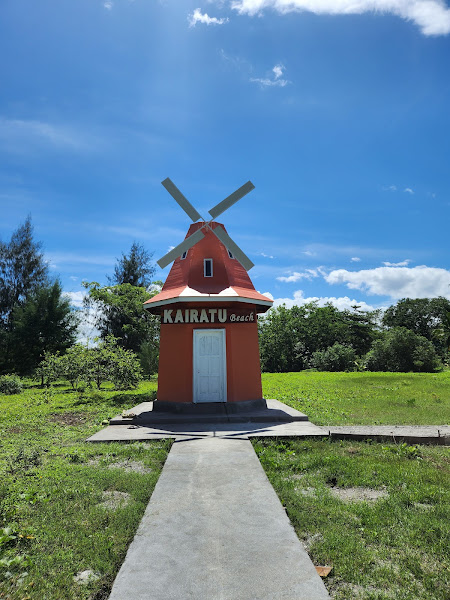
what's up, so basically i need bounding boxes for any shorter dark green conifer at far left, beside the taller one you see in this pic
[9,281,78,375]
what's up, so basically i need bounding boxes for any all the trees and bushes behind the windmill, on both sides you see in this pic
[0,218,450,385]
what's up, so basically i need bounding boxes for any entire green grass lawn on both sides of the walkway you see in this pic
[0,372,450,600]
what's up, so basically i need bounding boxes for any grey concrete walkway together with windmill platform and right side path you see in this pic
[89,400,450,600]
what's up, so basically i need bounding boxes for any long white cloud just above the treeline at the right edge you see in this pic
[324,265,450,299]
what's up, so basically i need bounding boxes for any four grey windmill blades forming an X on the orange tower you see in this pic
[157,177,255,271]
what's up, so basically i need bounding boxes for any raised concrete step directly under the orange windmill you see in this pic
[109,400,308,426]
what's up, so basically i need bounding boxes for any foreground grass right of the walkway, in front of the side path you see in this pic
[254,439,450,600]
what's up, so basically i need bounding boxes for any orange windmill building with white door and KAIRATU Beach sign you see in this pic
[144,179,272,410]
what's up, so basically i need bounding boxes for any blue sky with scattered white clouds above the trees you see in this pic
[0,0,450,318]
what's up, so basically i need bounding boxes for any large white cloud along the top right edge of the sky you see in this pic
[231,0,450,35]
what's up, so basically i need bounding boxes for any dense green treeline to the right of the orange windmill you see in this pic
[258,297,450,372]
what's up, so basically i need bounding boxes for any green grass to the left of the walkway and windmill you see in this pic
[0,381,170,600]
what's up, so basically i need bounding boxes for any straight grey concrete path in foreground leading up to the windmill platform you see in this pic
[110,438,329,600]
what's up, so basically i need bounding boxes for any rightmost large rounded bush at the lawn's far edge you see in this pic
[365,327,442,373]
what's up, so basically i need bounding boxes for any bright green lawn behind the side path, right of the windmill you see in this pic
[262,371,450,425]
